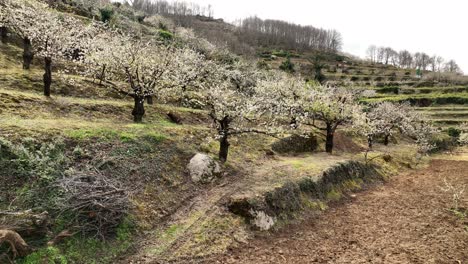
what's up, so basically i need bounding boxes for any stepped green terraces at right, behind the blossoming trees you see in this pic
[259,50,468,128]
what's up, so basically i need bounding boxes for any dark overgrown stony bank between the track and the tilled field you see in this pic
[227,161,383,230]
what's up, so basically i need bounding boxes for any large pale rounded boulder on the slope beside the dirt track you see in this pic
[187,153,221,183]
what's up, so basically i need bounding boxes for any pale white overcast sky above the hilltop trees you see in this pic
[158,0,468,74]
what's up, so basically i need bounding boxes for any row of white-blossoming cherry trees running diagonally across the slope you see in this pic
[0,0,433,161]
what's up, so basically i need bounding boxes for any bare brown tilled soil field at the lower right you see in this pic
[206,159,468,264]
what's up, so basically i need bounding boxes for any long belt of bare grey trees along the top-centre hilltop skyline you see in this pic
[126,0,343,53]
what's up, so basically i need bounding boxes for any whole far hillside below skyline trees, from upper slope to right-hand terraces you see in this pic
[183,14,468,128]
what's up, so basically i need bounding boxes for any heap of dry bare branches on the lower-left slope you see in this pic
[58,174,131,239]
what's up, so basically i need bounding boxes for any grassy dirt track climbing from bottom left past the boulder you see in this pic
[124,153,348,264]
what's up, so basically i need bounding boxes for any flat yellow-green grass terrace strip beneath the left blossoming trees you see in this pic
[0,88,206,142]
